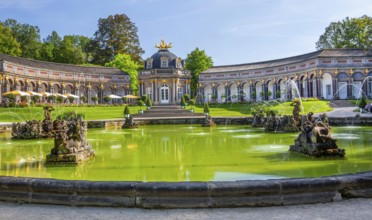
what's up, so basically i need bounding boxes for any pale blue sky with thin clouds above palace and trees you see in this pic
[0,0,372,65]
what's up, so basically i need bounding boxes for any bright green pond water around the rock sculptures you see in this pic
[0,125,372,182]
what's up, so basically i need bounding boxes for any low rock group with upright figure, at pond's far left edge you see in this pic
[12,106,54,139]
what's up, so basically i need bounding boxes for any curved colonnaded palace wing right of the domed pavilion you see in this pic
[198,49,372,103]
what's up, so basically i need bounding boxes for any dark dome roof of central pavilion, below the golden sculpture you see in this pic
[145,48,183,69]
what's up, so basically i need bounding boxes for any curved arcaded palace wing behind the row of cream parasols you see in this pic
[0,54,131,103]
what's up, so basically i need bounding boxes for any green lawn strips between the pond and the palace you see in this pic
[0,101,332,122]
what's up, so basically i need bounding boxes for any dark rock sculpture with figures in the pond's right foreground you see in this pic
[289,112,345,157]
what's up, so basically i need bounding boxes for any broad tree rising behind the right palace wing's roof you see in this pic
[316,15,372,49]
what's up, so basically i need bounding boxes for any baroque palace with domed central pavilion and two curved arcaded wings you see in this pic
[0,41,372,105]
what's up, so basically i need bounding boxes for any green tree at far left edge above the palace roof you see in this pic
[0,23,21,56]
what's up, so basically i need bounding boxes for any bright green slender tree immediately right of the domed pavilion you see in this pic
[185,48,213,97]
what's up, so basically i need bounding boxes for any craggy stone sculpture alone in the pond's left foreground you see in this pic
[46,112,94,164]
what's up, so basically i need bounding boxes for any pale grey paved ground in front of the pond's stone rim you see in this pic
[0,199,372,220]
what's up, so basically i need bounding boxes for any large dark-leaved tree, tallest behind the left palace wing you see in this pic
[89,14,144,64]
